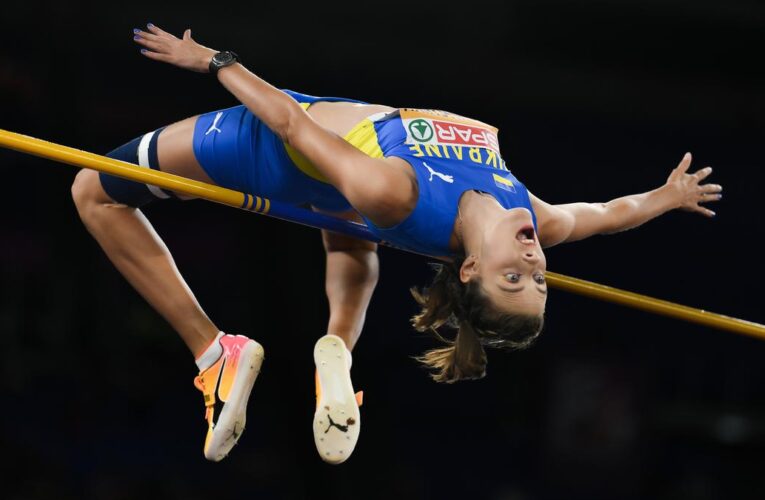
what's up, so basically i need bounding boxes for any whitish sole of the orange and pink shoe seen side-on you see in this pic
[205,340,265,462]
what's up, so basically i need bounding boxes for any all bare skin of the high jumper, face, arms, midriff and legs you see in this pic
[72,26,722,355]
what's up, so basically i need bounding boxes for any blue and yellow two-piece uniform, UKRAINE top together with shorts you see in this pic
[194,90,536,256]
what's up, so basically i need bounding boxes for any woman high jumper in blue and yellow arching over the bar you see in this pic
[72,24,722,463]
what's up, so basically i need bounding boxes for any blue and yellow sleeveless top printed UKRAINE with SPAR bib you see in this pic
[334,109,537,256]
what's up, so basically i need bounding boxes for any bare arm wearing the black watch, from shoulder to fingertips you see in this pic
[136,25,415,222]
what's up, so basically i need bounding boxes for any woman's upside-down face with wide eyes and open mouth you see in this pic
[461,208,547,316]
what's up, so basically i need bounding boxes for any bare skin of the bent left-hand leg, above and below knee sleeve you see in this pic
[72,118,219,357]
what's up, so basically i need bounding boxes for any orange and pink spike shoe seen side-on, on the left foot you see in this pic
[194,335,264,462]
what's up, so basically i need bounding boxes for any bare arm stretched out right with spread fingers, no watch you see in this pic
[529,153,722,247]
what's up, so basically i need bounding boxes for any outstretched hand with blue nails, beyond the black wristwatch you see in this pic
[133,23,218,73]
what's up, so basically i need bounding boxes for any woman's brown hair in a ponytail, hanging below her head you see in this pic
[410,260,544,383]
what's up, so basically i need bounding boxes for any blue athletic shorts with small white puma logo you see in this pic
[194,90,359,211]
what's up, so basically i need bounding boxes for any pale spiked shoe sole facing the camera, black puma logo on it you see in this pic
[313,335,361,464]
